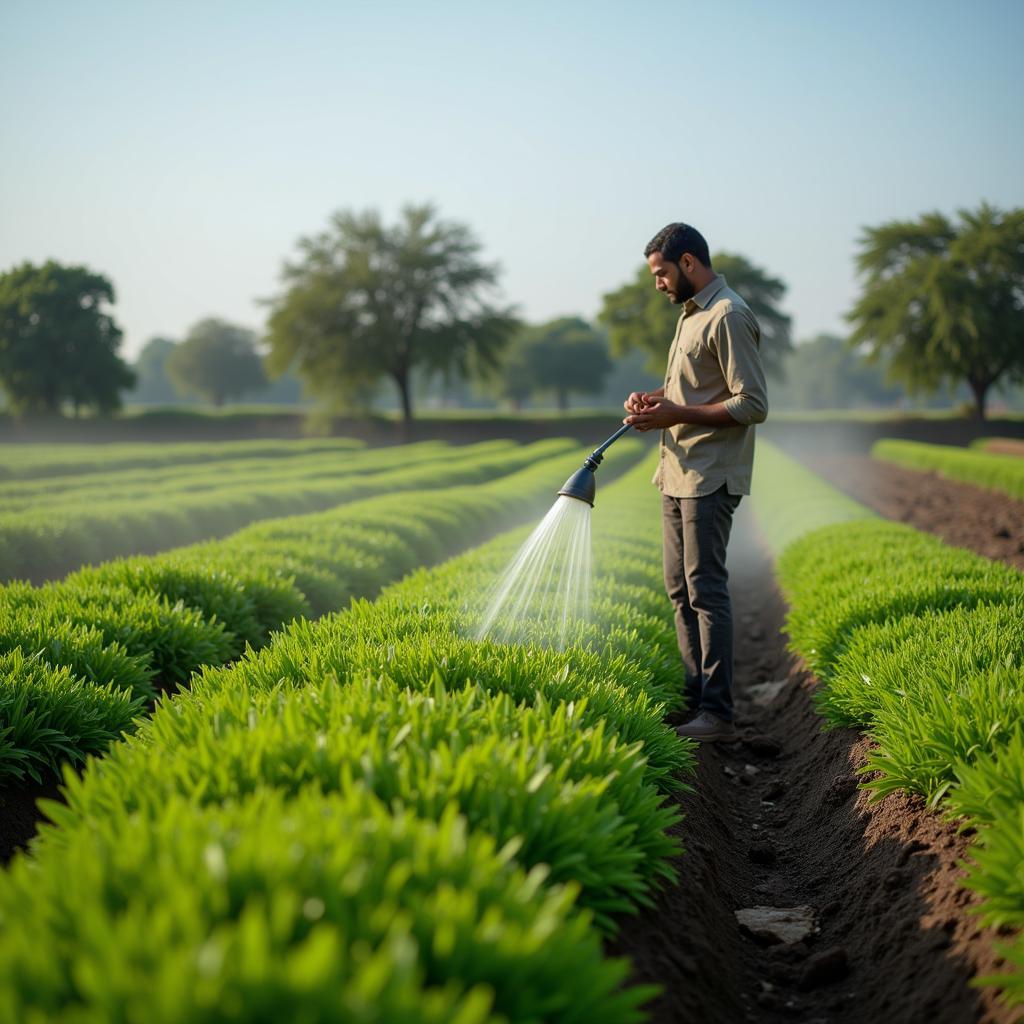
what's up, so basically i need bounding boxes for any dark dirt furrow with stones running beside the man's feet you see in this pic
[609,507,1018,1024]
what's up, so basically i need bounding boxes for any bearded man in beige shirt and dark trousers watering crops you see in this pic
[623,223,768,741]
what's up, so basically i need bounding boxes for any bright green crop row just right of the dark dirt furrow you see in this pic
[757,445,1024,1002]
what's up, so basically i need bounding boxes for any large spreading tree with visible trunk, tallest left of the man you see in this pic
[268,205,517,428]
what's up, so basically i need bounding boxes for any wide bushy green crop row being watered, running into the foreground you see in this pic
[0,452,692,1024]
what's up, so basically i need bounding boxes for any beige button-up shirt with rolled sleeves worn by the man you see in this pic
[653,274,768,498]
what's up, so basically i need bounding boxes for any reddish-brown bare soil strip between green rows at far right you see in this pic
[803,455,1024,569]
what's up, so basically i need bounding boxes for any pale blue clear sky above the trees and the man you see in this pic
[0,0,1024,354]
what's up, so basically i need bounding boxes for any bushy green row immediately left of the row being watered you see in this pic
[0,439,639,780]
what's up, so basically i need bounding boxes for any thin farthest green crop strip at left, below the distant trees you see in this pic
[0,437,364,480]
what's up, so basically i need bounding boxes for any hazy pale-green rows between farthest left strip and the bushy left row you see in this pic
[0,441,598,583]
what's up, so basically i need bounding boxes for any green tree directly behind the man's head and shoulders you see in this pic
[597,253,793,379]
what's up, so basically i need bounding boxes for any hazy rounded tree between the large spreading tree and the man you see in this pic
[498,316,611,410]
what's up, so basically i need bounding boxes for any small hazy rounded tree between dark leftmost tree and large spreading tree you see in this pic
[166,317,266,409]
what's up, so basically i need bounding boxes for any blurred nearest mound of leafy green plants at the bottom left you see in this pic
[0,786,650,1024]
